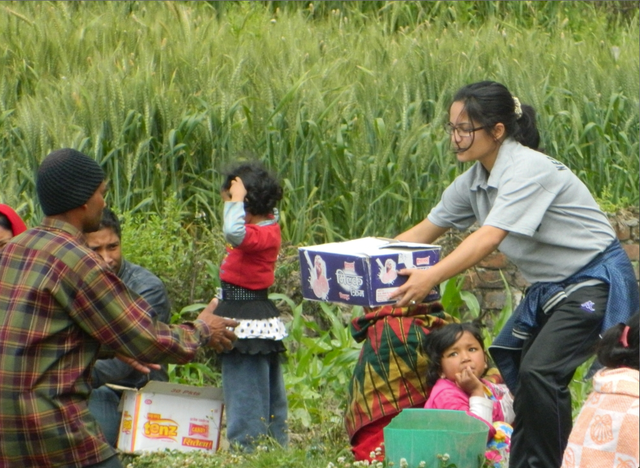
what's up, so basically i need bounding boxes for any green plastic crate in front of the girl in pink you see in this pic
[384,409,489,468]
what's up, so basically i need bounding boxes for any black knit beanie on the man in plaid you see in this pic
[36,148,105,216]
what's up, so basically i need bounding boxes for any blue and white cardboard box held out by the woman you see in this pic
[298,237,440,307]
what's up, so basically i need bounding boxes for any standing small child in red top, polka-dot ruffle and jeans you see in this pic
[215,162,288,451]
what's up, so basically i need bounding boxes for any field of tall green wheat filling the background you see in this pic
[0,1,640,244]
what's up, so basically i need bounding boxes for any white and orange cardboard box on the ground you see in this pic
[118,381,224,453]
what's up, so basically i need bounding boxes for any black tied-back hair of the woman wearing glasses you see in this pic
[453,81,540,150]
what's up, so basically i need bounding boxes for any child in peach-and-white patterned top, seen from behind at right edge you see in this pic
[562,313,640,468]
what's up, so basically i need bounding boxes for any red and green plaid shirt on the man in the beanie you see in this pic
[0,218,210,468]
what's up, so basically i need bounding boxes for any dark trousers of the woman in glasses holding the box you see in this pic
[509,284,609,468]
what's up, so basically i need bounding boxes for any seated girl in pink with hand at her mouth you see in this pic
[424,322,514,466]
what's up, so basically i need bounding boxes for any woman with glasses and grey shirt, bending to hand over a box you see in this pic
[394,81,639,468]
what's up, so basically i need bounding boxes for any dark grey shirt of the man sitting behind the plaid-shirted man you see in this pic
[91,259,171,388]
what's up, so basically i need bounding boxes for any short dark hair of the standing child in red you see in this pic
[222,161,282,216]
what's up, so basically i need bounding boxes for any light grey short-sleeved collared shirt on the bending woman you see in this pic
[428,138,616,283]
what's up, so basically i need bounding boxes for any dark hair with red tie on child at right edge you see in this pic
[596,312,640,369]
